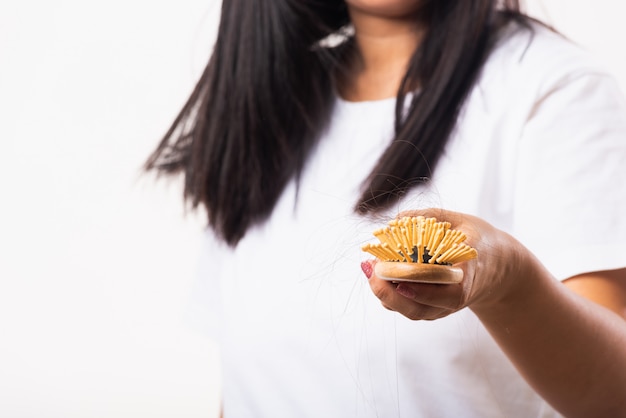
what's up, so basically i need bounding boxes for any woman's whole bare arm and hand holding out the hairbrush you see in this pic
[363,209,626,417]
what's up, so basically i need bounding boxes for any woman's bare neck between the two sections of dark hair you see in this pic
[338,9,424,101]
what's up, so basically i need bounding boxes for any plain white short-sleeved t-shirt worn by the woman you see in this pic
[189,23,626,418]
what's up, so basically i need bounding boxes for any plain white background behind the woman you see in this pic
[0,0,626,418]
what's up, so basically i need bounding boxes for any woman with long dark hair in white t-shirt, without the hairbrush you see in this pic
[147,0,626,417]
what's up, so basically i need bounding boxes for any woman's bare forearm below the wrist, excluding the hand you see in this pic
[472,260,626,417]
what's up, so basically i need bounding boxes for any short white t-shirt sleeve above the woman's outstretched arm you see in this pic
[513,71,626,280]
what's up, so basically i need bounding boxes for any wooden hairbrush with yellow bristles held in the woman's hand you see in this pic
[361,216,478,283]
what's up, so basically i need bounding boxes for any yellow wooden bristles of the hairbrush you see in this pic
[361,216,478,265]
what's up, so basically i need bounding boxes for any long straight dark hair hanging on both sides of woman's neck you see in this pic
[145,0,529,246]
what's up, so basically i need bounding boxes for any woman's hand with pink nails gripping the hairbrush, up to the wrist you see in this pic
[363,209,532,320]
